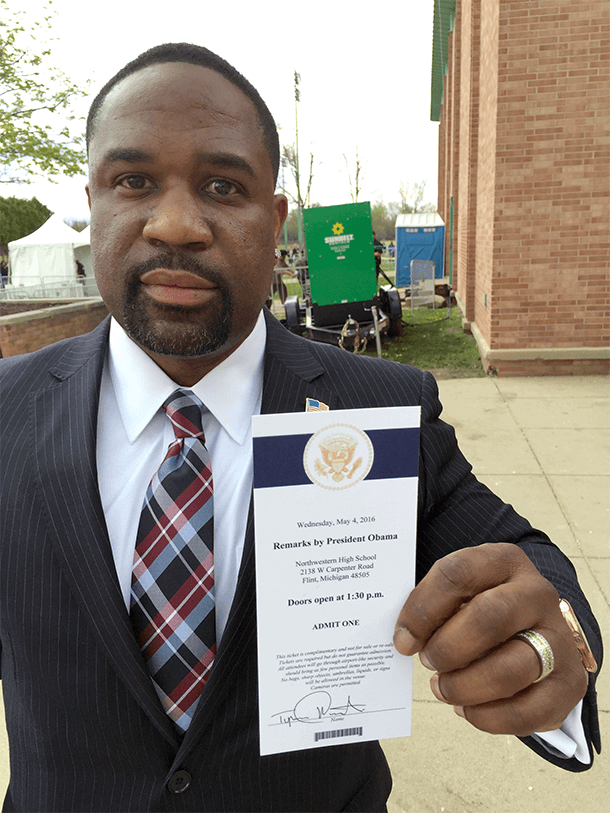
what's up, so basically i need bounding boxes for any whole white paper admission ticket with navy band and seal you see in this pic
[253,407,420,756]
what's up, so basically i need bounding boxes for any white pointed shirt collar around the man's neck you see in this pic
[108,312,267,444]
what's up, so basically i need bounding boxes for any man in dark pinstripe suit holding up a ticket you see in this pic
[0,46,601,811]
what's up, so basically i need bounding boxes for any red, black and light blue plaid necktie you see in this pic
[131,390,216,732]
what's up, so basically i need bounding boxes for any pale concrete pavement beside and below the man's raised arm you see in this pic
[0,376,610,813]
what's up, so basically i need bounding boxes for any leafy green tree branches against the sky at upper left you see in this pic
[0,0,86,183]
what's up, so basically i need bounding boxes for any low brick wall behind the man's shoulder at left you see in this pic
[0,302,108,358]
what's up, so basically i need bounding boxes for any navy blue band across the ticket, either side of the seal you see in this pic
[253,427,419,488]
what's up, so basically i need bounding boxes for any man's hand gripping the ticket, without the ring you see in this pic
[394,543,587,737]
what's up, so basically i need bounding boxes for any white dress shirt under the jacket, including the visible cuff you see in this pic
[97,313,590,765]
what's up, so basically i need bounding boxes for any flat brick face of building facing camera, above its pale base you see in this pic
[489,0,610,348]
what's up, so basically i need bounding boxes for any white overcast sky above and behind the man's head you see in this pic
[0,0,438,218]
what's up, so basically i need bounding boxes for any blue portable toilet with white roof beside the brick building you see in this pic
[396,212,445,288]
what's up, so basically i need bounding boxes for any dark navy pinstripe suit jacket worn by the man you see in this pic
[0,314,600,813]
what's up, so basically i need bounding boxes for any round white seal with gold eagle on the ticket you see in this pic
[303,423,373,489]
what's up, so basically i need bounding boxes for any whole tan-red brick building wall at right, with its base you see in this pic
[439,0,610,375]
